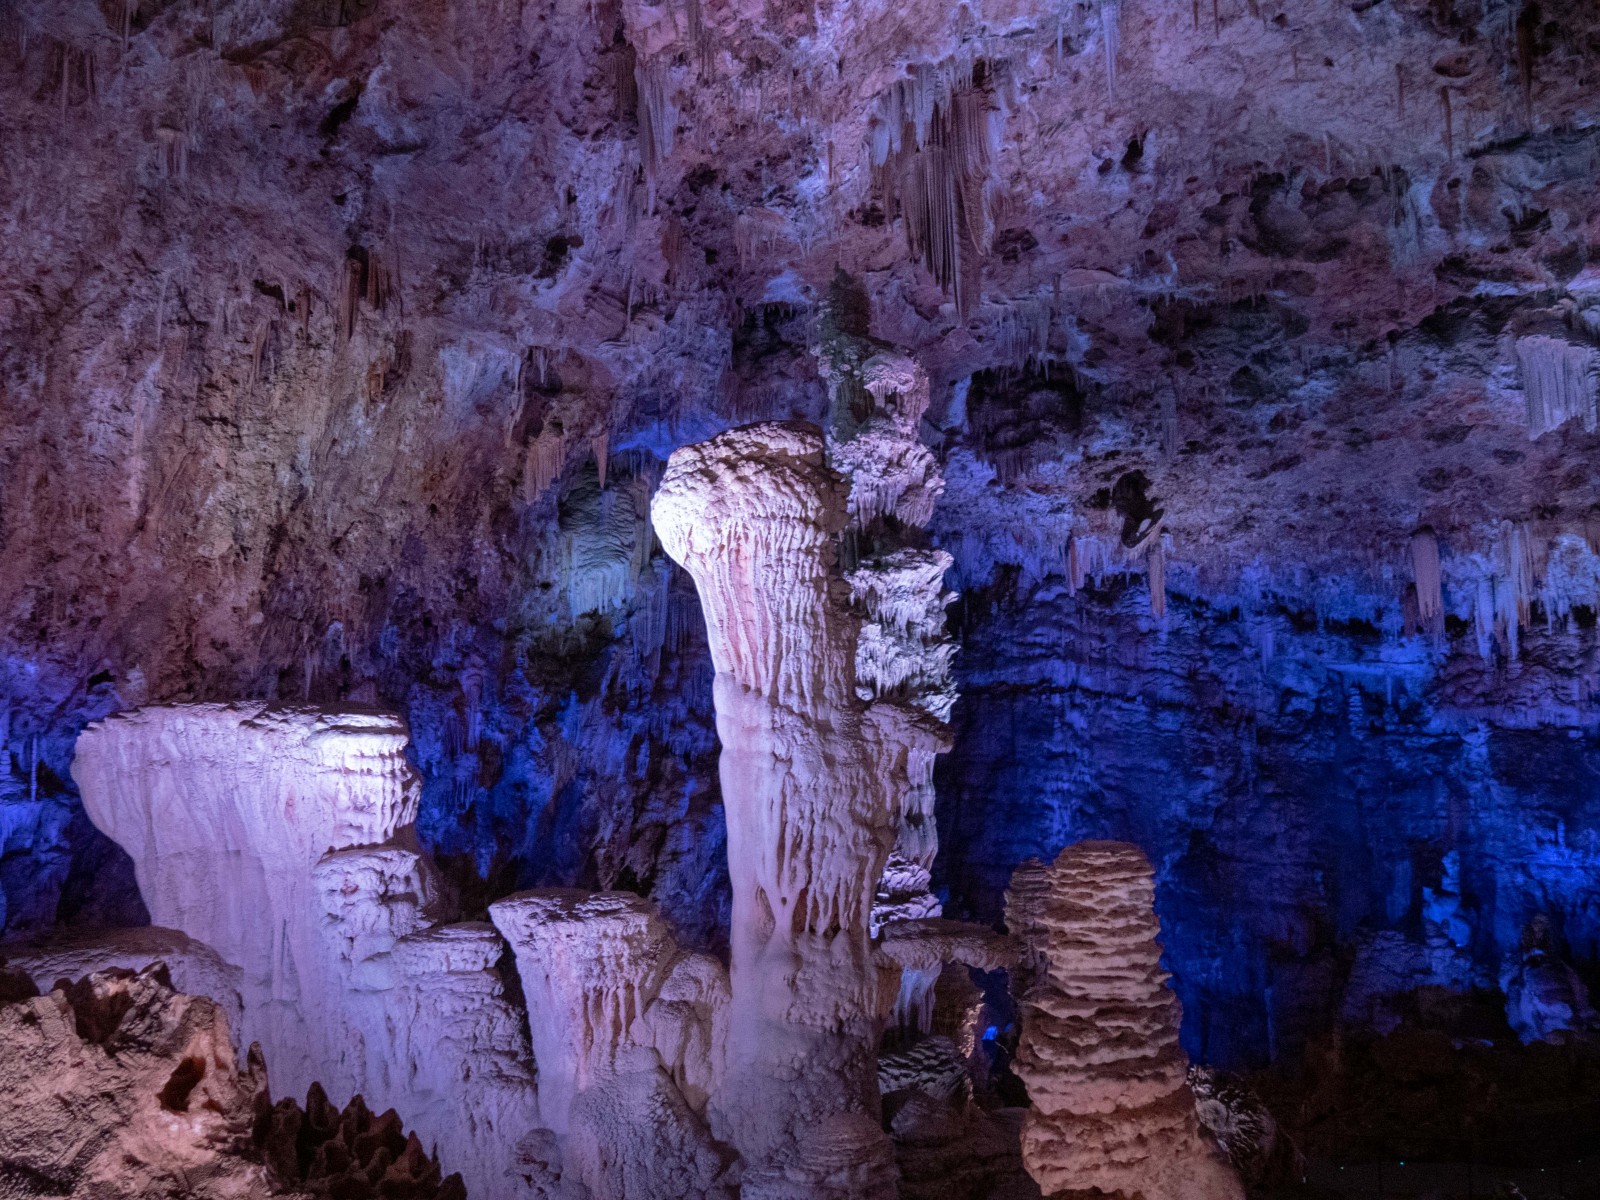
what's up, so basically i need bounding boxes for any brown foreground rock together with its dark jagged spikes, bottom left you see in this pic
[0,963,466,1200]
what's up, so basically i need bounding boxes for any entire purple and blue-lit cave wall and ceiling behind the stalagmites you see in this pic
[0,0,1600,1081]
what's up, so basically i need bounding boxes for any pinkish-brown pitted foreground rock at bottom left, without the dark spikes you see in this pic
[0,968,277,1200]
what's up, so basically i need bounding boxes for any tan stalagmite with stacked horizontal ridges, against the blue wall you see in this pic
[1006,842,1243,1200]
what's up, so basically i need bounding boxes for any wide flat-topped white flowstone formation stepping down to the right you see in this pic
[72,704,536,1195]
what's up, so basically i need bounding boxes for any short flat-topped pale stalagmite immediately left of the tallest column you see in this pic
[490,888,731,1200]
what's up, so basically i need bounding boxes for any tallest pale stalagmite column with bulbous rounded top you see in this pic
[651,424,904,1200]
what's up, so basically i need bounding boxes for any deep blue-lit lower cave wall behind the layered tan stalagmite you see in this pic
[939,579,1600,1067]
